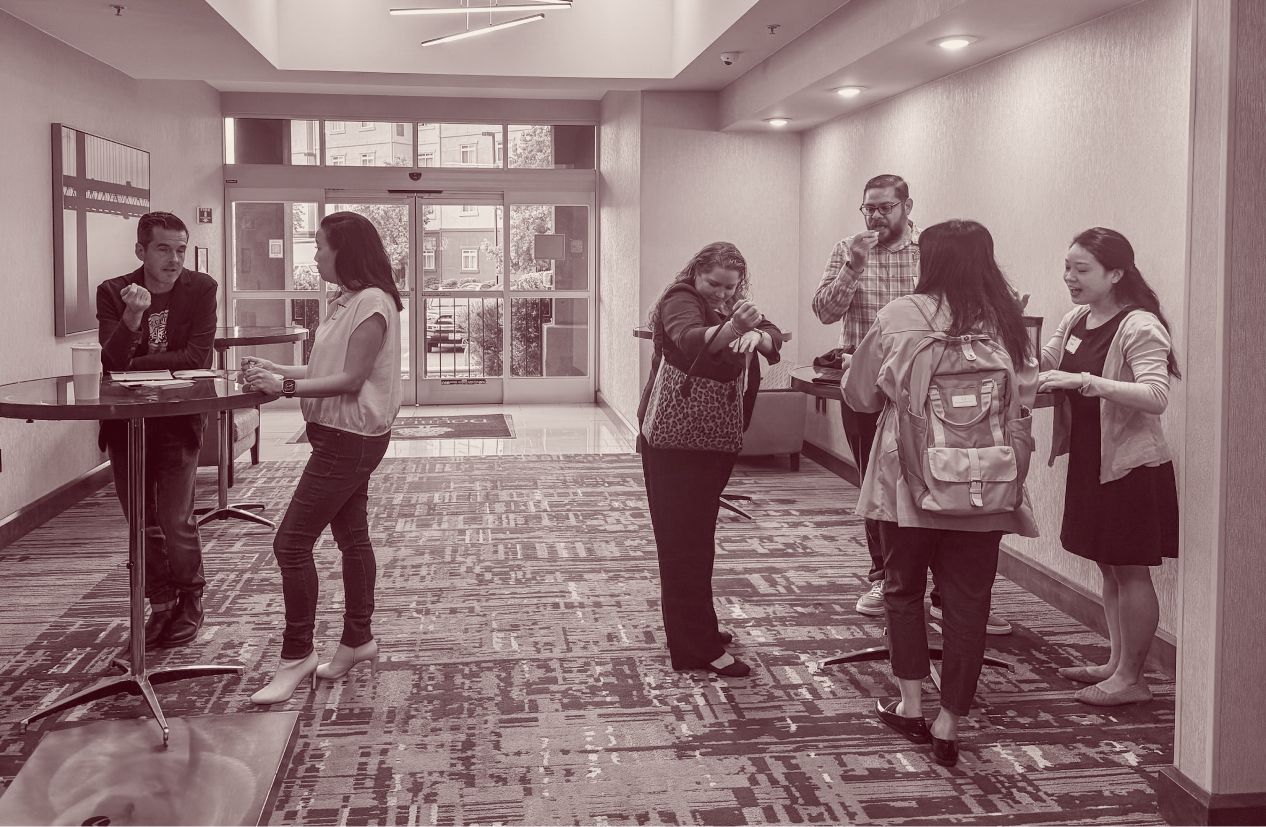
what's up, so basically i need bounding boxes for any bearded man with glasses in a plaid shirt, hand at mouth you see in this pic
[813,175,919,617]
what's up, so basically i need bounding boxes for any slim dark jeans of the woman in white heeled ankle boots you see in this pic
[272,422,391,660]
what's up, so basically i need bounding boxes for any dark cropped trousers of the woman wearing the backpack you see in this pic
[880,522,1003,716]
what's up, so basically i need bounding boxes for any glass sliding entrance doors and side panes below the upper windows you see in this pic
[228,190,594,405]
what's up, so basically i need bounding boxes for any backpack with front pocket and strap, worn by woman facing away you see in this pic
[896,299,1034,517]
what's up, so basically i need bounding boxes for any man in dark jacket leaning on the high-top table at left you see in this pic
[96,213,216,648]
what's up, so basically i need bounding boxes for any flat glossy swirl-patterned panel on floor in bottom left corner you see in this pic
[0,712,299,824]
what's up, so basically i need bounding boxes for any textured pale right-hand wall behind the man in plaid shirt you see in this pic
[798,0,1191,633]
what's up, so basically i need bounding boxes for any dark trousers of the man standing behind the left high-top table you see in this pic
[105,419,206,607]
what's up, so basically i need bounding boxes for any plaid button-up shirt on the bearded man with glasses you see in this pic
[813,222,919,353]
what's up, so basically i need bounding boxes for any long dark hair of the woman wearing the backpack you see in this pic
[914,219,1033,366]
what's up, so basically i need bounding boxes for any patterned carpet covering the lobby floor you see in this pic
[0,456,1174,824]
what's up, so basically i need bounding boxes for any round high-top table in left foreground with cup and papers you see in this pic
[0,376,272,746]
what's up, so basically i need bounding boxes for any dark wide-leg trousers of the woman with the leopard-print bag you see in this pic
[638,436,737,669]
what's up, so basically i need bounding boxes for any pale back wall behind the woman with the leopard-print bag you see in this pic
[600,92,800,422]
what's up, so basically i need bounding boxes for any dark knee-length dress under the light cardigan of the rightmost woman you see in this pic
[1060,309,1179,566]
